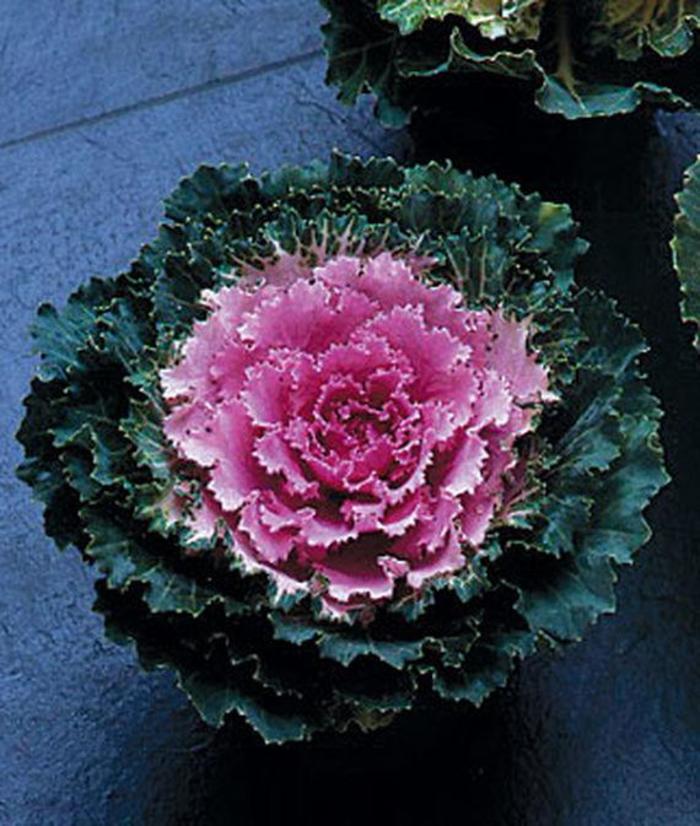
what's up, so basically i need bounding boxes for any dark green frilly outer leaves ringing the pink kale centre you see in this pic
[18,154,666,742]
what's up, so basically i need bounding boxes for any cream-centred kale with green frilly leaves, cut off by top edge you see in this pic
[322,0,700,126]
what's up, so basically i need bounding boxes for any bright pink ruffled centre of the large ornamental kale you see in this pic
[160,253,554,616]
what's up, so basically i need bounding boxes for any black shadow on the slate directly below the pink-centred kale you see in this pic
[152,694,515,826]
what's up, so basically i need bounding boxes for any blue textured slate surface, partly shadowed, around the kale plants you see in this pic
[0,0,700,826]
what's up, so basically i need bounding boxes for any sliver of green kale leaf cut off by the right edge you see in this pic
[671,153,700,350]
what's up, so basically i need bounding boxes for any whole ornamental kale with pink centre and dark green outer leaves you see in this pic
[19,154,666,741]
